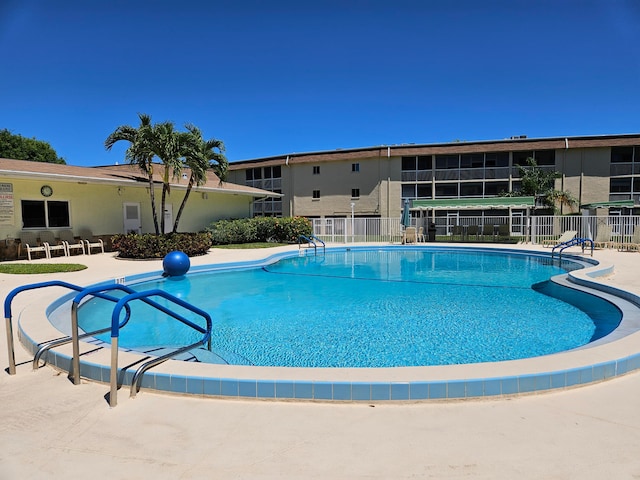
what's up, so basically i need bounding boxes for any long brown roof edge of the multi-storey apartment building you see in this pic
[229,133,640,170]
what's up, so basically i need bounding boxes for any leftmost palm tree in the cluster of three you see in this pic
[104,113,164,235]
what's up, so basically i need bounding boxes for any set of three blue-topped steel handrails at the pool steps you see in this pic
[4,280,212,407]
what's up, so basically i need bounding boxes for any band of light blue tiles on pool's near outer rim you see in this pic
[18,328,640,402]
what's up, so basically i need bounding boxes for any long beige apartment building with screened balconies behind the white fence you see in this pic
[228,134,640,219]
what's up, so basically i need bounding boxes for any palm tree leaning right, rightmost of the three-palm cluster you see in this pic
[173,124,229,233]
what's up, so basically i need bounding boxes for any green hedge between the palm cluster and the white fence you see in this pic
[207,217,313,245]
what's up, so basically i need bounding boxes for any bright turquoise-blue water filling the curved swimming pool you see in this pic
[74,248,621,367]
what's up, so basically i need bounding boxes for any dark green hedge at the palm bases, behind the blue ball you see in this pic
[111,232,212,258]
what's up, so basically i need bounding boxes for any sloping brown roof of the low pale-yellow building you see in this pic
[0,158,282,197]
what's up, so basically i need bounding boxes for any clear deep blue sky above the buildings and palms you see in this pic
[0,0,640,165]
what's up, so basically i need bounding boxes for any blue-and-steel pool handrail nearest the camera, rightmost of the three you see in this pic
[109,289,212,407]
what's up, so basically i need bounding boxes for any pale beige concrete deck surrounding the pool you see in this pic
[0,245,640,479]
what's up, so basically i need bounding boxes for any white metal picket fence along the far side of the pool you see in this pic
[313,215,640,247]
